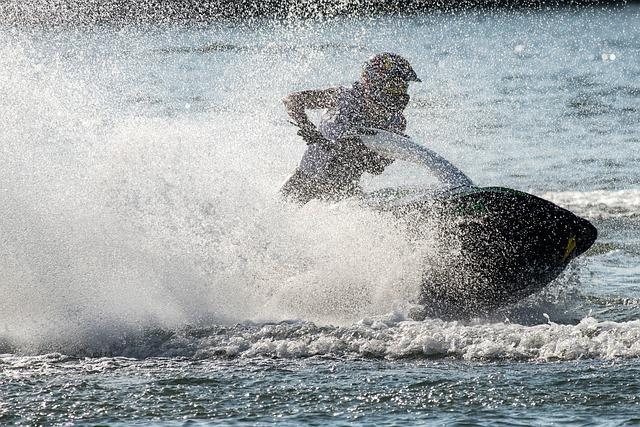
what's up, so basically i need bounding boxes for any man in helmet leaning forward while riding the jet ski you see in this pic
[281,53,420,204]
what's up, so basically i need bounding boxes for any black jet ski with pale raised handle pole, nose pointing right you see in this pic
[354,129,597,318]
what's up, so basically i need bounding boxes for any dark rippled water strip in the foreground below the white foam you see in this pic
[4,355,640,425]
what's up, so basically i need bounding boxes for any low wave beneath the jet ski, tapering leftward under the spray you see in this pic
[5,313,640,361]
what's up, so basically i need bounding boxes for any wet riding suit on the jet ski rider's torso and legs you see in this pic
[281,82,406,204]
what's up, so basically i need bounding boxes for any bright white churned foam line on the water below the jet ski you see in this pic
[198,317,640,360]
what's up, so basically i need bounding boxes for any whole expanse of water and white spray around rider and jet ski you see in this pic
[0,6,640,425]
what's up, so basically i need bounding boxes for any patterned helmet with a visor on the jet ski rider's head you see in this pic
[362,52,421,111]
